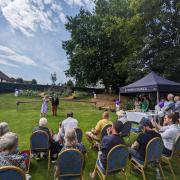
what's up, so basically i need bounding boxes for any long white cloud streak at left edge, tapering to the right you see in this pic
[0,45,37,66]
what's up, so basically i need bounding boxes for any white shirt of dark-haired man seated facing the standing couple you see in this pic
[62,117,78,134]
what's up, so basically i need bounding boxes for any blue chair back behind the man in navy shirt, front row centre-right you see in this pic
[106,145,129,174]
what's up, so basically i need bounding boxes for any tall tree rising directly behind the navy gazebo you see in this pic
[116,0,180,81]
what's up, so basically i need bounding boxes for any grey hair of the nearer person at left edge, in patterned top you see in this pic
[0,132,18,151]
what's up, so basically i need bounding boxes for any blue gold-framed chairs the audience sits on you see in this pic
[0,125,180,180]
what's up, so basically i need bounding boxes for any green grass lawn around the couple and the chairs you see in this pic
[0,94,180,180]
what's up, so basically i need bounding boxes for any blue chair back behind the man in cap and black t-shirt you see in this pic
[144,137,164,165]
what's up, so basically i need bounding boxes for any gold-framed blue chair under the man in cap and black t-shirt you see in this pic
[131,137,165,180]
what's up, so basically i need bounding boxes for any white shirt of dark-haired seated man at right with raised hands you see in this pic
[159,124,180,151]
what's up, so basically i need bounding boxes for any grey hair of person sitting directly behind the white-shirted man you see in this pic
[64,129,78,146]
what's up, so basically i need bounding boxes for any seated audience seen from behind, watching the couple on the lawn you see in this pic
[0,107,180,178]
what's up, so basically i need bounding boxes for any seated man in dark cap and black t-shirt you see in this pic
[129,118,161,161]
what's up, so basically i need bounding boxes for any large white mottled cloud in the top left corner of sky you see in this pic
[0,0,59,36]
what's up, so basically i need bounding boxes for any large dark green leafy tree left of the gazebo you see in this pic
[63,0,127,88]
